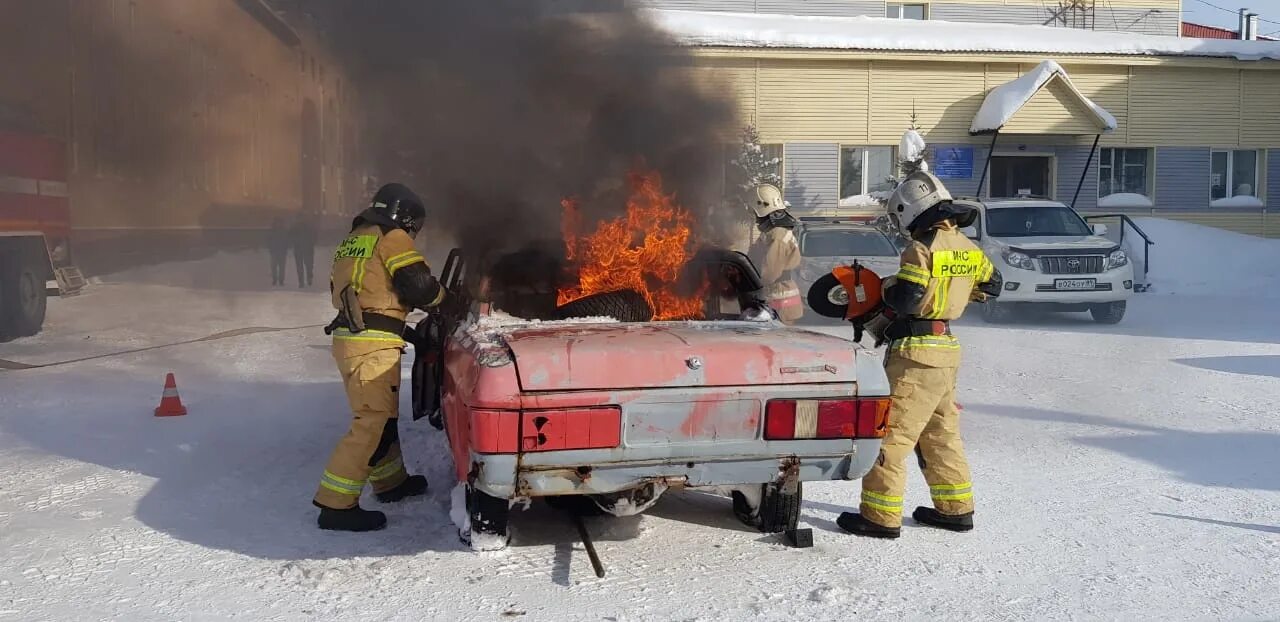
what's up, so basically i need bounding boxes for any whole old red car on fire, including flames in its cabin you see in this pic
[413,177,888,549]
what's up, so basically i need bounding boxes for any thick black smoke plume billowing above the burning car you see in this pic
[305,0,736,248]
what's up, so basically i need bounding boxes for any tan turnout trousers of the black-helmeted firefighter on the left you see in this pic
[315,340,408,509]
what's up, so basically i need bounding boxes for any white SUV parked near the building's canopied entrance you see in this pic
[956,198,1133,324]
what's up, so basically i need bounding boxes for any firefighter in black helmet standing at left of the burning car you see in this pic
[312,183,447,531]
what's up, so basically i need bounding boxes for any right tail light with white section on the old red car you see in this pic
[764,398,890,440]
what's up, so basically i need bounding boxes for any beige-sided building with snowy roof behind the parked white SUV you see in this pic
[650,10,1280,235]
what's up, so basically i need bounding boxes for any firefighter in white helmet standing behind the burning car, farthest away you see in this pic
[748,183,804,324]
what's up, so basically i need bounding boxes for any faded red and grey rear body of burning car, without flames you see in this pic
[419,245,888,547]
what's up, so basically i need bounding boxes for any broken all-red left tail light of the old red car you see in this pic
[471,406,622,453]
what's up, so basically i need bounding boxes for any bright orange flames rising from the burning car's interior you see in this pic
[557,171,707,320]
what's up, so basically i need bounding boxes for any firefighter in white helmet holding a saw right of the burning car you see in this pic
[837,171,1001,538]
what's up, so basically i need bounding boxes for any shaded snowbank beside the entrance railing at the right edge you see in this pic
[1134,218,1280,298]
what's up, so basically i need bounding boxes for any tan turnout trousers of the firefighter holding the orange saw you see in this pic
[860,347,973,527]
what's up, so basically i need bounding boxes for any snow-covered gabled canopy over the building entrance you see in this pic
[969,60,1116,136]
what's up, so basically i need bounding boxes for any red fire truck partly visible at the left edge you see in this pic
[0,129,84,340]
